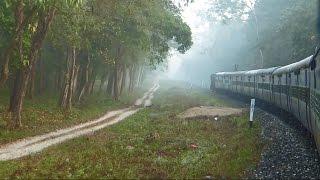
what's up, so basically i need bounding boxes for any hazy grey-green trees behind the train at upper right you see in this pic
[243,0,319,68]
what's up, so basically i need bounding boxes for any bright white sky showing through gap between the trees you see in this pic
[166,0,256,79]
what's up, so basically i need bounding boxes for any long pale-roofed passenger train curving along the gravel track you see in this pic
[210,49,320,154]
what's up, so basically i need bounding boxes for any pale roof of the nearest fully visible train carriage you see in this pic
[273,56,313,75]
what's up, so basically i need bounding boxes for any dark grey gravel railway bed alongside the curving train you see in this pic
[212,93,320,179]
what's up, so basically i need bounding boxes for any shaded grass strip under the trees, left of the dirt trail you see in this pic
[0,87,143,144]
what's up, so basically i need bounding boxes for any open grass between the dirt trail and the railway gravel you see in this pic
[0,82,263,179]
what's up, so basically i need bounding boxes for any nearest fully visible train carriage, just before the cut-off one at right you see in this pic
[273,56,312,130]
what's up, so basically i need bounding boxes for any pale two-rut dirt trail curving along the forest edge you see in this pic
[0,84,160,161]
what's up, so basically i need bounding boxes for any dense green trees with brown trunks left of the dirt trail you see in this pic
[0,0,192,128]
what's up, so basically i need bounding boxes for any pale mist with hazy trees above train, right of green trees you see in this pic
[163,0,318,86]
